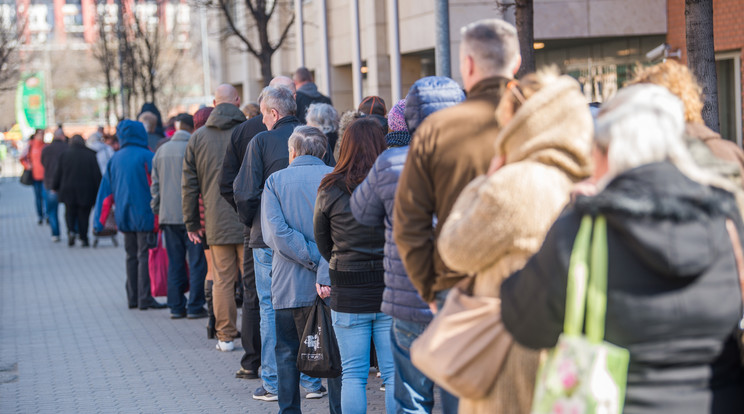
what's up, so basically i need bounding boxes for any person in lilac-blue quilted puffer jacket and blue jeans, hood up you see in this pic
[351,76,465,414]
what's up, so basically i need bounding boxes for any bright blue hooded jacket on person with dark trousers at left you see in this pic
[93,119,155,232]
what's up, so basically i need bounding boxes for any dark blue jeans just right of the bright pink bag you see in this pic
[160,224,207,314]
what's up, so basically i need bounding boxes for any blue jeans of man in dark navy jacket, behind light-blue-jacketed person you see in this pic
[253,248,322,395]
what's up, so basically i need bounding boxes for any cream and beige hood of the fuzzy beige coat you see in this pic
[496,73,594,180]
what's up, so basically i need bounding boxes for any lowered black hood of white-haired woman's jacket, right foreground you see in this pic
[575,162,738,278]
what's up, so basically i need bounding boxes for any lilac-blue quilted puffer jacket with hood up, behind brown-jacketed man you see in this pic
[351,76,465,323]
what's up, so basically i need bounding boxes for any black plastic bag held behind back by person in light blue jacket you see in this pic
[297,296,341,378]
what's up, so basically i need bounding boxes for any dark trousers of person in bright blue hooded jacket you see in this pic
[122,231,157,308]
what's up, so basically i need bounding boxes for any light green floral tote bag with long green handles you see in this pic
[532,215,630,414]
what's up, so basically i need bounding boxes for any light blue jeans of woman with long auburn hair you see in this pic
[331,311,395,414]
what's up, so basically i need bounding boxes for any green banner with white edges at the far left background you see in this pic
[16,72,46,131]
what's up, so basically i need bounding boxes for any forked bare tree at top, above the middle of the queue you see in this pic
[208,0,295,85]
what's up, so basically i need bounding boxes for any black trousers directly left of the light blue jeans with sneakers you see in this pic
[240,231,261,374]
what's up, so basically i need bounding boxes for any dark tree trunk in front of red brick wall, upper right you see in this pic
[685,0,720,132]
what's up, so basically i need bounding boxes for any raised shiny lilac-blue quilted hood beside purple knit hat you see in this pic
[405,76,465,136]
